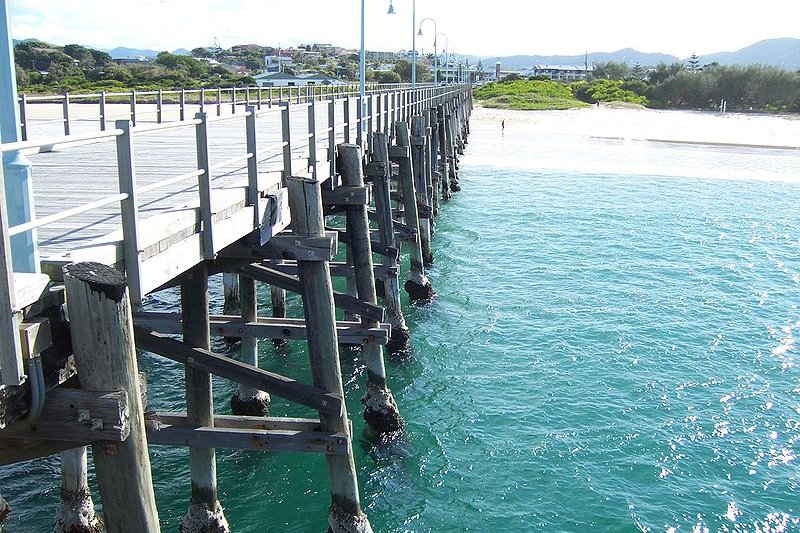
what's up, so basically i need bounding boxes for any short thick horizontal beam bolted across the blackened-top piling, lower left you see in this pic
[0,388,131,447]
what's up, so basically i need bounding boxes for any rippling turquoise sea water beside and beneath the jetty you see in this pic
[0,121,800,533]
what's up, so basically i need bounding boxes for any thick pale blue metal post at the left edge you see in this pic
[0,0,40,272]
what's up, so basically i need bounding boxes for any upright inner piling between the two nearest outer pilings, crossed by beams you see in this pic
[180,263,230,533]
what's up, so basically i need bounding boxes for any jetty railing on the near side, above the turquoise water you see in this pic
[0,82,468,374]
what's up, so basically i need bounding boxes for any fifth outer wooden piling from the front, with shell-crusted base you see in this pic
[395,122,436,302]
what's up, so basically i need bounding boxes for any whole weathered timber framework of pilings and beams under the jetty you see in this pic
[0,84,472,533]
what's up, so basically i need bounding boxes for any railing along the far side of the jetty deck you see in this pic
[18,83,432,141]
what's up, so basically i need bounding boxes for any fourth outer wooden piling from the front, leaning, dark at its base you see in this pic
[371,132,410,352]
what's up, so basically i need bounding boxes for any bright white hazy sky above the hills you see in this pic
[4,0,800,58]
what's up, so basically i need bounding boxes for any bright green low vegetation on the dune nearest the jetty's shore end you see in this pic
[475,80,588,111]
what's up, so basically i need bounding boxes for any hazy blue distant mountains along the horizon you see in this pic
[14,37,800,71]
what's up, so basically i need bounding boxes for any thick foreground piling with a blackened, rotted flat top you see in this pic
[63,263,160,533]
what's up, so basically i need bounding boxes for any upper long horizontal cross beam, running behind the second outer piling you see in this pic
[134,312,391,345]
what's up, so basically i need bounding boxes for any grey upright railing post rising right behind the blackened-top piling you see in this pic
[114,120,143,308]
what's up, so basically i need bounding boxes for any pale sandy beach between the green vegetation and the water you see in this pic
[470,104,800,149]
